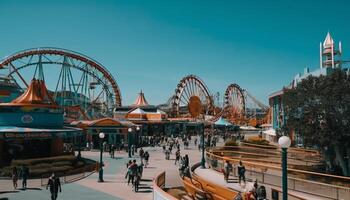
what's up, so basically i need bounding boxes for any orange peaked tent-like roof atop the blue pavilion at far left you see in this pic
[1,79,58,108]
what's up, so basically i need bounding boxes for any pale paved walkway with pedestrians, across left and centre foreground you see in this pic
[0,140,201,200]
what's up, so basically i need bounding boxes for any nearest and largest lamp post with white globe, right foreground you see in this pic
[278,136,291,200]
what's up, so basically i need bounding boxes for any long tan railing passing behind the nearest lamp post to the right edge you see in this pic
[206,151,350,199]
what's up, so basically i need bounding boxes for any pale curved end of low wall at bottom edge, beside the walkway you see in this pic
[153,171,177,200]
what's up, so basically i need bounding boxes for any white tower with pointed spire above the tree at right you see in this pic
[320,32,342,68]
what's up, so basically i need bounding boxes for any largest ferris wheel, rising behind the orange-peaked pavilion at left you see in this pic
[0,48,121,119]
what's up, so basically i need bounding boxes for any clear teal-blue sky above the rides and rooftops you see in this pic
[0,0,350,104]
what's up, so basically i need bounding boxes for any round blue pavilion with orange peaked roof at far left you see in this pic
[0,78,82,166]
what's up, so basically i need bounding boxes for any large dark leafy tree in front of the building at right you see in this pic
[282,69,350,176]
